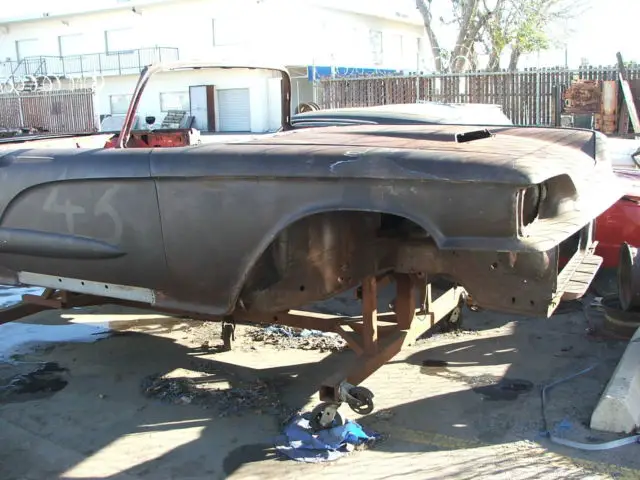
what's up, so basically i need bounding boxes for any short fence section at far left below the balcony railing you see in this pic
[0,88,97,133]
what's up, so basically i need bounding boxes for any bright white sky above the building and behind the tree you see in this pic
[1,0,640,67]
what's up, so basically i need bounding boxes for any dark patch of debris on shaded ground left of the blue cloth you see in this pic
[141,371,288,417]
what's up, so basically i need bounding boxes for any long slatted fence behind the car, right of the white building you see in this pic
[315,66,640,125]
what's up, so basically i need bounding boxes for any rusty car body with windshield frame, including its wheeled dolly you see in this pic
[0,62,624,424]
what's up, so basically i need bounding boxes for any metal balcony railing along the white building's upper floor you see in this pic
[0,47,179,79]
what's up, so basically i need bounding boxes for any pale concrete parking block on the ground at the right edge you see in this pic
[591,328,640,433]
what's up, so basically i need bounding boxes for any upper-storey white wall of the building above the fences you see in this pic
[0,0,430,69]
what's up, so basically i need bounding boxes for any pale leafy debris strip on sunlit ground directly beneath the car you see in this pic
[247,325,347,352]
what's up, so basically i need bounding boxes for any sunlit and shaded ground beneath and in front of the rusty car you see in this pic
[0,284,640,480]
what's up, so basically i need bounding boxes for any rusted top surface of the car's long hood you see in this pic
[219,125,596,184]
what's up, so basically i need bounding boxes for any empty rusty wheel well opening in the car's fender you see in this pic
[239,210,428,311]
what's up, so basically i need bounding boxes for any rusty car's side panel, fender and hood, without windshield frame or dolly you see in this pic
[0,121,622,315]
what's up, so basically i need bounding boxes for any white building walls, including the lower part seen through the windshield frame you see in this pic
[0,0,428,132]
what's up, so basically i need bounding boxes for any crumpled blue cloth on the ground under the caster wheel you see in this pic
[275,413,379,463]
